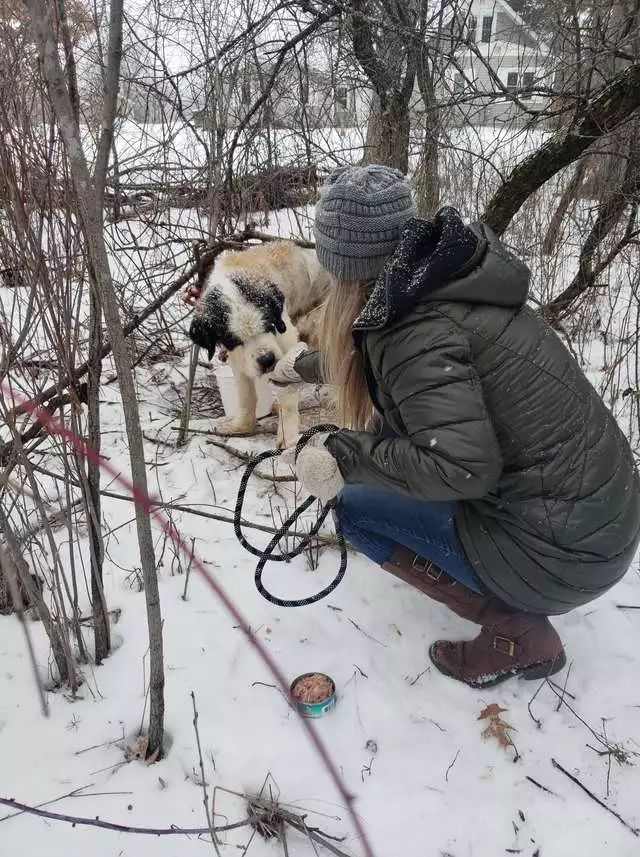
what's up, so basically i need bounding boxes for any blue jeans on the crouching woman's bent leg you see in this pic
[336,485,487,593]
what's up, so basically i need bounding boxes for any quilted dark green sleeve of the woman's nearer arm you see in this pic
[327,313,502,501]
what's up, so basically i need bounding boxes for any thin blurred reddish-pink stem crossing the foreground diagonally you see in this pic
[0,383,375,857]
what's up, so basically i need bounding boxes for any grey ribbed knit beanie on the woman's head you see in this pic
[314,164,416,280]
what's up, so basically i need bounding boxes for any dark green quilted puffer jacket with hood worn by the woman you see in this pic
[320,209,640,614]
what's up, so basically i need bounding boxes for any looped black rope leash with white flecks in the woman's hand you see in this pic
[233,424,347,607]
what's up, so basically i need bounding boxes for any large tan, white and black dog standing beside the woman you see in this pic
[189,241,331,449]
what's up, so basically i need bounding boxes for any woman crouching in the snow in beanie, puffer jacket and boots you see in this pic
[273,166,640,687]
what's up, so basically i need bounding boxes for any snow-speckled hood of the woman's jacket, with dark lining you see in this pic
[353,207,531,331]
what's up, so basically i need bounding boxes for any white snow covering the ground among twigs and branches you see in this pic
[0,127,640,857]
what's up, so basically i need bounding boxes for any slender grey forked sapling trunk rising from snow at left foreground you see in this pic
[27,0,164,755]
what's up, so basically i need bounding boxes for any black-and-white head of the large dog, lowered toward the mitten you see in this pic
[189,269,288,378]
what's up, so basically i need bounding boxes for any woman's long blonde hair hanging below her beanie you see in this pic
[320,280,373,431]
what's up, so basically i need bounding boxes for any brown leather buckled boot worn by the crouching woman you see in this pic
[383,547,566,688]
